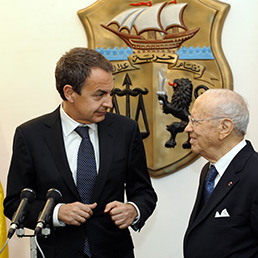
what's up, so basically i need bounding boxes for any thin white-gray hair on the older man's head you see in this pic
[207,89,249,136]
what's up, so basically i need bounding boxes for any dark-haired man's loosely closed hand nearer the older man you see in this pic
[104,201,138,229]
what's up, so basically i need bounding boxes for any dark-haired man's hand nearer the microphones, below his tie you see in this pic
[58,202,97,226]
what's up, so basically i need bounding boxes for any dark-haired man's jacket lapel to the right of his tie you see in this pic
[92,114,116,202]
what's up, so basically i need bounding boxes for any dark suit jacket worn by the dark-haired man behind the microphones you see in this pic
[4,108,157,258]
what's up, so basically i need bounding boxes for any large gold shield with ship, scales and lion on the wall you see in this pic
[78,0,233,177]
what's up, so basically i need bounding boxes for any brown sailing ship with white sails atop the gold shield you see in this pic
[101,2,200,53]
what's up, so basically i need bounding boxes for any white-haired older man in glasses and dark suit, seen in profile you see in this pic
[184,89,258,258]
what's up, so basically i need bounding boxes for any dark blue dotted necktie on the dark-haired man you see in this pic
[75,126,97,257]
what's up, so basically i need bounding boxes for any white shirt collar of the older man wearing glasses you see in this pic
[213,139,246,176]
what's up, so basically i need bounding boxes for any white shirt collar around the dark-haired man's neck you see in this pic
[60,104,97,137]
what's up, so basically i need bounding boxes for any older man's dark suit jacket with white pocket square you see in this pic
[184,141,258,258]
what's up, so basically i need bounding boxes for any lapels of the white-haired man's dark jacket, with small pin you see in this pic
[189,141,254,230]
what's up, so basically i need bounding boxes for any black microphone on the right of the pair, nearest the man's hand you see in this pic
[35,188,62,236]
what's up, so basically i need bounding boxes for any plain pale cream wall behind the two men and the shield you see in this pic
[0,0,258,258]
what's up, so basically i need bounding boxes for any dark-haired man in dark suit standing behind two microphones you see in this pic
[4,48,157,258]
